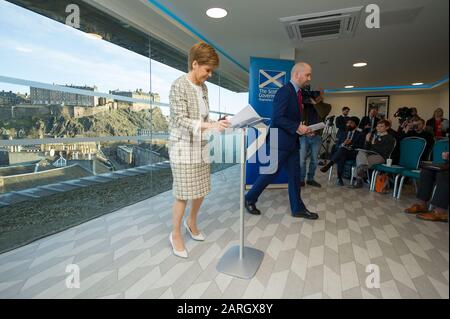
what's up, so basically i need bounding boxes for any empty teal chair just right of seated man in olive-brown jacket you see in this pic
[372,137,427,198]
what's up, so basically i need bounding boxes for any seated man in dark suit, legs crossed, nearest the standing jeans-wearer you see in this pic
[320,116,364,186]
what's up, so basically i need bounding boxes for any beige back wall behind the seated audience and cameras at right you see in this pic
[325,83,449,129]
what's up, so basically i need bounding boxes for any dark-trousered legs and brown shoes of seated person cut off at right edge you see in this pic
[405,152,448,222]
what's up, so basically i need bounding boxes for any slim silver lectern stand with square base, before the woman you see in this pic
[217,119,264,279]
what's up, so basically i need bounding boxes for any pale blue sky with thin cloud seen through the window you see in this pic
[0,0,248,113]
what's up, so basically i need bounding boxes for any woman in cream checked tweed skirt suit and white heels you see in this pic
[168,42,230,258]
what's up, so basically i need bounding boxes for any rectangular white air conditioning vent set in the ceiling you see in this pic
[280,7,363,42]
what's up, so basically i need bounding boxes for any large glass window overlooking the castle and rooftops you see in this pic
[0,0,248,252]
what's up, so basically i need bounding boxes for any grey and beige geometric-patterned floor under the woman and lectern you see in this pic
[0,166,449,298]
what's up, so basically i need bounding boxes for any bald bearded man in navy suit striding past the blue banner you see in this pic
[245,62,318,219]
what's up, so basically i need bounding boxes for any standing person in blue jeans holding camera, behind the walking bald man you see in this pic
[300,88,331,187]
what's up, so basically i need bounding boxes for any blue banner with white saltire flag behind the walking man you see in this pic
[246,57,295,185]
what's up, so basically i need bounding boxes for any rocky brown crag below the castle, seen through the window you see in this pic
[0,108,168,138]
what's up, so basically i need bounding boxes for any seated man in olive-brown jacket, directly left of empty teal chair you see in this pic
[351,120,395,188]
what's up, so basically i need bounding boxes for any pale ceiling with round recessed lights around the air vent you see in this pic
[85,0,449,89]
